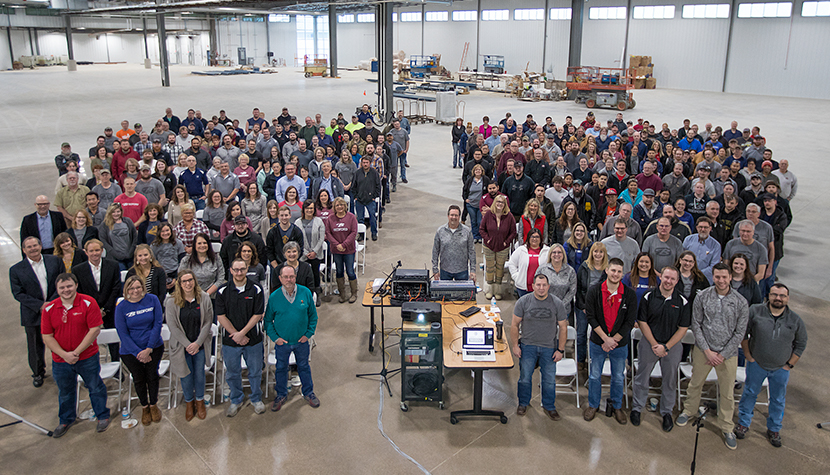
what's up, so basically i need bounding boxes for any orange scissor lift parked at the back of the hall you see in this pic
[566,66,637,111]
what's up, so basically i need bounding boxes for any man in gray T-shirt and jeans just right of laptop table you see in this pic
[510,274,568,421]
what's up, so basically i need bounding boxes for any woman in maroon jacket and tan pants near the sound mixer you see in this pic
[479,195,517,300]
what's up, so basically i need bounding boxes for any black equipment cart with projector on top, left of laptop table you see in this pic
[400,320,444,412]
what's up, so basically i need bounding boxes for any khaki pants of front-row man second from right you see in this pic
[683,346,738,432]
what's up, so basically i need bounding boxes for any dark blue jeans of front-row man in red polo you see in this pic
[52,353,110,424]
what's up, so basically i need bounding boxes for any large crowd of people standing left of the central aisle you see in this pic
[10,105,410,437]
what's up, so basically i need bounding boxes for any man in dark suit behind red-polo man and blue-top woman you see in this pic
[72,239,121,361]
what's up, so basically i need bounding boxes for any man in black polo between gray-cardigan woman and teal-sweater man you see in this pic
[216,259,265,417]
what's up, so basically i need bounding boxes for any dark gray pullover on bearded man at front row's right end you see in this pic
[746,303,807,371]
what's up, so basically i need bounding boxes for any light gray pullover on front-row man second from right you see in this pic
[692,286,749,358]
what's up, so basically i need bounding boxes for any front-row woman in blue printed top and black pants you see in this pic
[115,275,164,426]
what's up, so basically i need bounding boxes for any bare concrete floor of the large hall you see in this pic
[0,65,830,474]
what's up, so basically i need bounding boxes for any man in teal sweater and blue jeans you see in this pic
[265,266,320,412]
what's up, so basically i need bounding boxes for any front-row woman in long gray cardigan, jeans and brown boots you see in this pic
[164,270,213,422]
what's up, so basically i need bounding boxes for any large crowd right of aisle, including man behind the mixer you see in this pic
[442,112,806,449]
